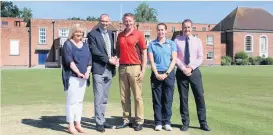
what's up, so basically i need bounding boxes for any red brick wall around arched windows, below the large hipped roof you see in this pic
[233,32,273,57]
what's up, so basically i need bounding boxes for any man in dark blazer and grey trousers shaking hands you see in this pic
[87,14,118,132]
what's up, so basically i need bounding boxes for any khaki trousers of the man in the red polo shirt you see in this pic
[119,65,144,124]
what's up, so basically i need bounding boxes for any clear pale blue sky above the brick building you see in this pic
[14,1,273,24]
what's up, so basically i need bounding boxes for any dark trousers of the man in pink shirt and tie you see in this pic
[176,68,207,125]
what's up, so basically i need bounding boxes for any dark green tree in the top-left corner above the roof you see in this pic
[1,1,20,17]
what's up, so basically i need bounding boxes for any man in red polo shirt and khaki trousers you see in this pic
[116,13,147,131]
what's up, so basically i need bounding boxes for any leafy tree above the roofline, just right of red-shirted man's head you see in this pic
[135,2,158,22]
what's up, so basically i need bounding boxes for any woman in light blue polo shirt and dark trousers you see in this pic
[148,23,177,131]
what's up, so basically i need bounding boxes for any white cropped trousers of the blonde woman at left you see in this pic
[66,76,87,123]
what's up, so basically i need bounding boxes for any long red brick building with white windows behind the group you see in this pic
[1,8,273,67]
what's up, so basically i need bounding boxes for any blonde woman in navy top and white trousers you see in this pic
[62,24,92,134]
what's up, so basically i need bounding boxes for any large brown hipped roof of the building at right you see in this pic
[212,7,273,31]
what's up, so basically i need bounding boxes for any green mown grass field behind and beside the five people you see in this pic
[1,66,273,135]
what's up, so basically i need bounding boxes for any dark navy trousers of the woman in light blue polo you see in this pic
[151,70,175,125]
